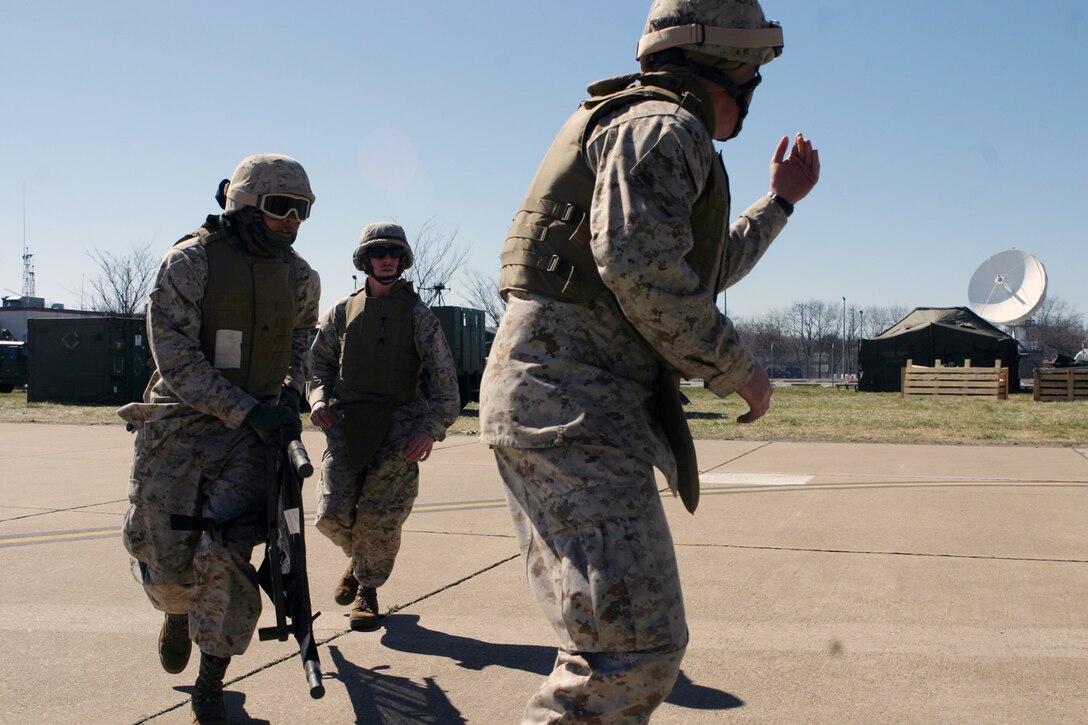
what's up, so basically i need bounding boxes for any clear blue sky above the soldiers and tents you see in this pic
[0,0,1088,324]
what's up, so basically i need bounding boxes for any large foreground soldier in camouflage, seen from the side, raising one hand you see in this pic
[481,0,819,723]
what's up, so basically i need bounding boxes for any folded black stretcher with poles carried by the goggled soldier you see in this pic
[257,431,325,699]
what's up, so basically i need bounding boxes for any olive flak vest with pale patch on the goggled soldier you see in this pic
[177,218,296,400]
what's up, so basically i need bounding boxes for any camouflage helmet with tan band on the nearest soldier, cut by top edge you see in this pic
[635,0,782,65]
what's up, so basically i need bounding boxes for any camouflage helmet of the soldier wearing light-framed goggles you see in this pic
[224,153,317,221]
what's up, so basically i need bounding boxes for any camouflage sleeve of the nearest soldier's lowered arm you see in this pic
[586,109,772,396]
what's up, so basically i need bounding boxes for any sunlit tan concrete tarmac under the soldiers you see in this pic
[0,425,1088,725]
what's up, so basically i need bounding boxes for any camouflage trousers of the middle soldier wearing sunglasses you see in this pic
[316,425,419,589]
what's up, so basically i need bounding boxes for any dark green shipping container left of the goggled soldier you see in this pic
[26,317,151,405]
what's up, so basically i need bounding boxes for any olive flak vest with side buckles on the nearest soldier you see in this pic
[498,73,729,513]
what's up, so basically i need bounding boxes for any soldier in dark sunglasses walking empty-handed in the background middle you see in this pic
[309,222,460,629]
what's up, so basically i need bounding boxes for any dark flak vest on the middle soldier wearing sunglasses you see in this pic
[334,280,422,405]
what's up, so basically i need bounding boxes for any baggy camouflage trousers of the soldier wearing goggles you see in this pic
[123,416,265,656]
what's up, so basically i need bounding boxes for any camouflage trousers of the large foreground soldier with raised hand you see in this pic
[494,439,688,724]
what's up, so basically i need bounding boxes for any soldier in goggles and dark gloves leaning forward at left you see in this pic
[119,155,320,722]
